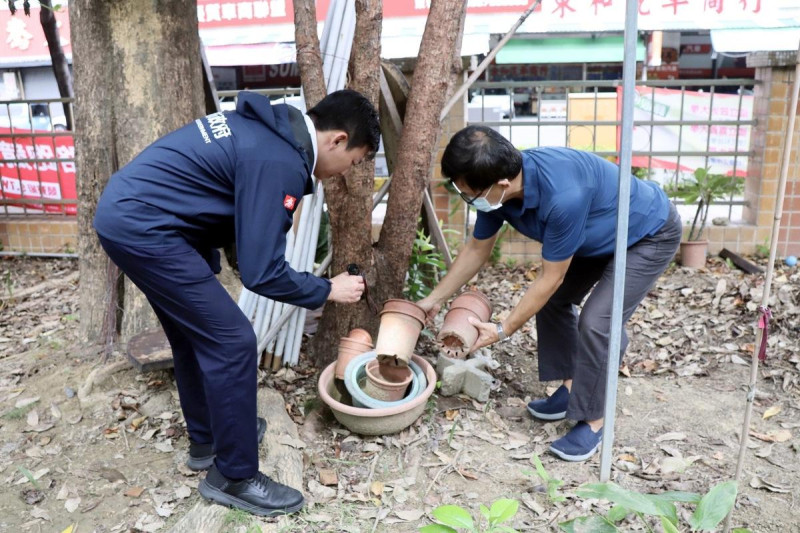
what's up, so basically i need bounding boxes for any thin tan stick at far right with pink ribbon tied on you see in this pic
[724,41,800,533]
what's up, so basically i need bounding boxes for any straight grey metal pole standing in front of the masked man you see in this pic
[600,0,639,482]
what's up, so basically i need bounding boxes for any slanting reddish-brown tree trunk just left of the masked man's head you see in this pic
[374,0,466,301]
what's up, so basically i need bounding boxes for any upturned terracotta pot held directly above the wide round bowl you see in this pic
[375,300,425,366]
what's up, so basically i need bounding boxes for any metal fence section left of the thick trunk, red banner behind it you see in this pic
[0,98,77,216]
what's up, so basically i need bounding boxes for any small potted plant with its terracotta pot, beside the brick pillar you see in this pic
[667,168,744,268]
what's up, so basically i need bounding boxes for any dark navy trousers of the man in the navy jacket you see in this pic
[100,233,258,479]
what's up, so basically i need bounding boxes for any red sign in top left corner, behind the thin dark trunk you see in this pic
[0,6,72,62]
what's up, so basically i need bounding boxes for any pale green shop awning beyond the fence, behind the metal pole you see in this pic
[495,36,645,65]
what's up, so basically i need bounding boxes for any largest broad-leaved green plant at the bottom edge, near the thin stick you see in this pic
[559,481,746,533]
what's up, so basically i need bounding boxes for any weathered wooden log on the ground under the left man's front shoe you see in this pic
[170,389,305,533]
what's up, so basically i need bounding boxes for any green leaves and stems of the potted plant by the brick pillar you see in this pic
[666,168,744,241]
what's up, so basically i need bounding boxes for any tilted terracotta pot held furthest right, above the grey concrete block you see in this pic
[436,291,492,359]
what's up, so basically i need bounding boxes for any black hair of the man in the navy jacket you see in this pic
[308,89,381,154]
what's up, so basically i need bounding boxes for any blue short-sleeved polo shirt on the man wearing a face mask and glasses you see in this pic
[473,147,669,261]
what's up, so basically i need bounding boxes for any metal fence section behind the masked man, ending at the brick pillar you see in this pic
[467,79,758,219]
